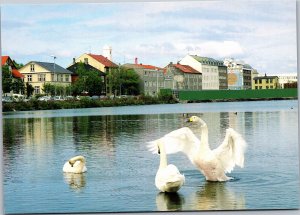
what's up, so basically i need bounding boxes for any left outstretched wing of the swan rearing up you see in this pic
[147,127,200,157]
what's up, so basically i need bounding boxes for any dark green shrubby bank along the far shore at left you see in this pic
[2,95,177,112]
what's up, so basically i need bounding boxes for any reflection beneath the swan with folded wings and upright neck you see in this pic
[156,192,184,211]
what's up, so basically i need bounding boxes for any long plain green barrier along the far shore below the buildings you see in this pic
[178,88,298,102]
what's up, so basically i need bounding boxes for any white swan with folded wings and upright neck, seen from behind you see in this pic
[155,142,185,192]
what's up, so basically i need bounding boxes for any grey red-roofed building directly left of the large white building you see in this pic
[164,63,202,90]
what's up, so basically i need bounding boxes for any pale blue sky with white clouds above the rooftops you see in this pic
[1,0,297,75]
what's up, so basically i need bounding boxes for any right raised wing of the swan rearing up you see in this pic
[213,128,247,172]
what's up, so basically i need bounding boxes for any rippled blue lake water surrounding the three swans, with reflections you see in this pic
[3,100,299,213]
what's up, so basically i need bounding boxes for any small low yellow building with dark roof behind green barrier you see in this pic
[252,74,279,89]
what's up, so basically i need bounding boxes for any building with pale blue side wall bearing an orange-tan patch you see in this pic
[224,58,256,90]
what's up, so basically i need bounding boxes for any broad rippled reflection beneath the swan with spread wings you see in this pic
[190,182,245,210]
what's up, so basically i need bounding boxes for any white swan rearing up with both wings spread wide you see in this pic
[148,116,247,181]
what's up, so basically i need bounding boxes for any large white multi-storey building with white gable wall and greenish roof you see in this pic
[179,55,227,90]
